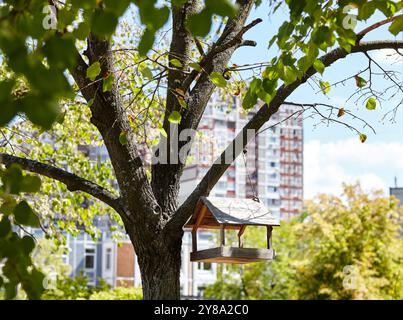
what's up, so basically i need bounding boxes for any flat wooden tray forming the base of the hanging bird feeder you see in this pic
[190,247,275,264]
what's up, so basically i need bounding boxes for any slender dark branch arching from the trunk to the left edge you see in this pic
[0,153,124,214]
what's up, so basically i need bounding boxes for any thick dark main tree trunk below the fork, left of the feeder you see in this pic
[136,232,183,300]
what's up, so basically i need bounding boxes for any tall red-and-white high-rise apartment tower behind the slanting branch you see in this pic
[181,98,303,219]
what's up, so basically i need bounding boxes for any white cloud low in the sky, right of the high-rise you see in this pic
[304,139,403,198]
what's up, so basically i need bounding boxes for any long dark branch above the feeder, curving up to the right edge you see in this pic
[167,40,403,230]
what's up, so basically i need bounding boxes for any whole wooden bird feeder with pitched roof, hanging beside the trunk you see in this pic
[184,197,280,264]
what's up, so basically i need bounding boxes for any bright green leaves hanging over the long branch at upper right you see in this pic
[243,0,402,140]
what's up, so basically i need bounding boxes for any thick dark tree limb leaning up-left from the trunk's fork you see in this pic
[69,33,161,238]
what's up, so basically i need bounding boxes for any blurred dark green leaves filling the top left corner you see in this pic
[0,0,235,129]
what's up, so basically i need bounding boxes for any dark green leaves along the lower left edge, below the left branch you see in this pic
[0,165,44,299]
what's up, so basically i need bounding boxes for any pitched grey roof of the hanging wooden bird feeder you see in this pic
[185,197,280,229]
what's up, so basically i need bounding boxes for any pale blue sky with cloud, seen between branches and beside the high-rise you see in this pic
[232,1,403,198]
